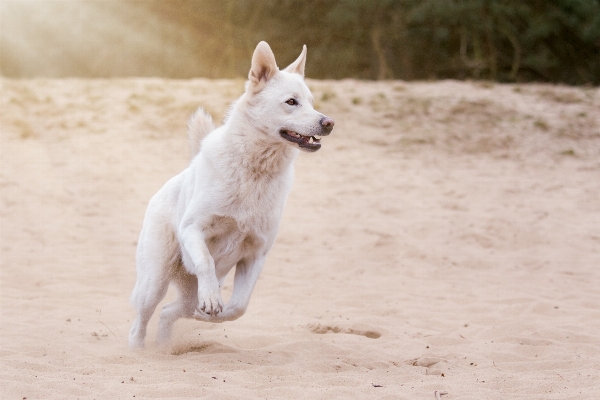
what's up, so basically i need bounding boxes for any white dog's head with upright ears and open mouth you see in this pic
[246,42,334,152]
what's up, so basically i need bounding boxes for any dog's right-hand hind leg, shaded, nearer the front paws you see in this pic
[156,266,198,344]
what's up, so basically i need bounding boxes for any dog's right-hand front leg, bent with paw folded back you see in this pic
[194,256,265,322]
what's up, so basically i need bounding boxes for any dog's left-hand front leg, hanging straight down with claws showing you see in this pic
[179,221,223,317]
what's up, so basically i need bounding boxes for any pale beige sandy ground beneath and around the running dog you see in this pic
[0,79,600,400]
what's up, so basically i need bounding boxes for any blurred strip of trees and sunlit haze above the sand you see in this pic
[0,0,600,85]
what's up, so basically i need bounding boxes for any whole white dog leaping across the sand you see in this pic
[129,42,334,347]
